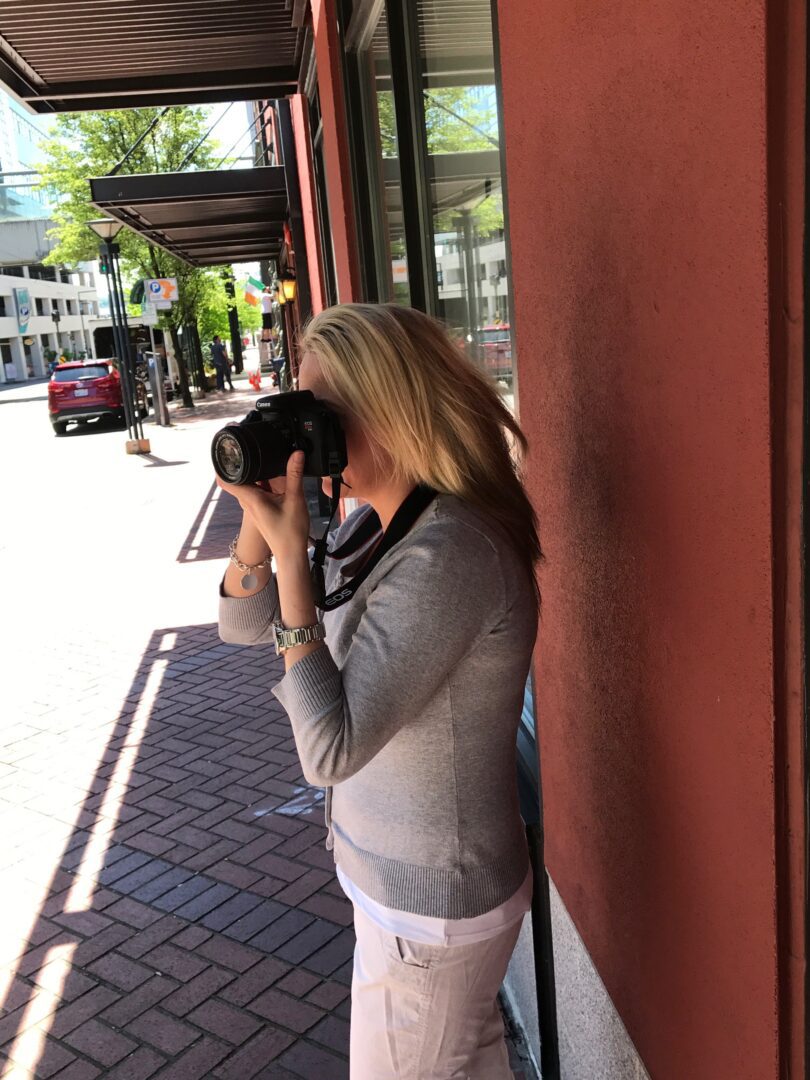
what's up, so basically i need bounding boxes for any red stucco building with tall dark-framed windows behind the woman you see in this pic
[258,0,808,1080]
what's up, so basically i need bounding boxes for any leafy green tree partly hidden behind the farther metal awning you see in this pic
[41,106,233,407]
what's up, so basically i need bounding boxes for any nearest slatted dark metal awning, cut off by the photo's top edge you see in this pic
[0,0,308,112]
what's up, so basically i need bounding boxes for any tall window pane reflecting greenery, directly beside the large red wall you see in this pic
[418,0,514,406]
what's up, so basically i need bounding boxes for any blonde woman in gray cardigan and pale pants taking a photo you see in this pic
[220,305,540,1080]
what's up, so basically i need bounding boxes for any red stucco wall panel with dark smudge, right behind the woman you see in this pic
[499,0,790,1080]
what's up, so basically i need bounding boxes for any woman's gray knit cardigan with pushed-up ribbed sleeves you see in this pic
[219,496,537,919]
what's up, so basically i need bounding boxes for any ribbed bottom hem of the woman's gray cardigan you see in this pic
[333,822,529,919]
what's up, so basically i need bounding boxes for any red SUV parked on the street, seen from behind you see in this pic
[48,360,149,435]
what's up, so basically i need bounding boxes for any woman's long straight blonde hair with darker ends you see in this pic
[301,303,542,600]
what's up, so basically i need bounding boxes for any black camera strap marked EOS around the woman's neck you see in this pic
[312,480,436,611]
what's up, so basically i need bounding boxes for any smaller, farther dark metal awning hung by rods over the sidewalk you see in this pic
[90,165,287,267]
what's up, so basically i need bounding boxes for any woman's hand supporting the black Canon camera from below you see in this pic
[217,450,310,564]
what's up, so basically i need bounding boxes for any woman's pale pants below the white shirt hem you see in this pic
[350,906,521,1080]
